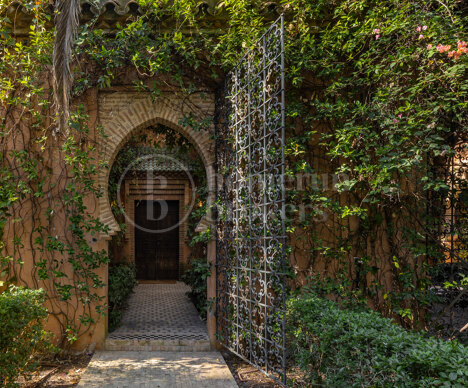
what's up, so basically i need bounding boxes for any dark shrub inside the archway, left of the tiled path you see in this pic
[109,264,137,331]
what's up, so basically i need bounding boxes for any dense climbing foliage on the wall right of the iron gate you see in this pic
[283,0,468,326]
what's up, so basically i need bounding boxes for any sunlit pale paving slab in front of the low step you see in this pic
[78,351,238,388]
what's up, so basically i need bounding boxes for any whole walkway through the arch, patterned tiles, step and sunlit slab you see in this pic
[78,282,237,388]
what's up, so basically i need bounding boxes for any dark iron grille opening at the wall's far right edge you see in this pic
[426,135,468,342]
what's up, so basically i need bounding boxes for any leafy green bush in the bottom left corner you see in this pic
[0,286,50,387]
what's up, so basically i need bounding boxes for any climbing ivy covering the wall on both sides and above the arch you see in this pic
[0,0,468,341]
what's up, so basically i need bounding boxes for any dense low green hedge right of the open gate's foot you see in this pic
[288,293,468,387]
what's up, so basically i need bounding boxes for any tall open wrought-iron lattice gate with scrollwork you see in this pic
[216,17,286,385]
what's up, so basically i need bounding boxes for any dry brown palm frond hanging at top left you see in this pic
[53,0,81,130]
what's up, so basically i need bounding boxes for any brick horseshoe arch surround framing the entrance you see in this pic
[98,92,216,346]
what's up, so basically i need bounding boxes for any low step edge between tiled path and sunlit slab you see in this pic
[104,338,212,352]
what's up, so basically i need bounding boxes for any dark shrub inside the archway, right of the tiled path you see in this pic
[182,259,211,318]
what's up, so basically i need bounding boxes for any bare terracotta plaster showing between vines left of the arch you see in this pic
[2,90,107,348]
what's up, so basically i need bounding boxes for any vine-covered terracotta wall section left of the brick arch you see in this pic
[0,1,108,347]
